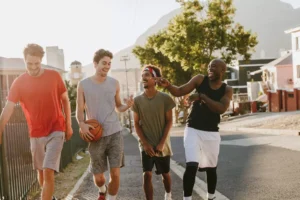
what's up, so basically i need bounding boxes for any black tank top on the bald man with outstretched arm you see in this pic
[187,76,226,131]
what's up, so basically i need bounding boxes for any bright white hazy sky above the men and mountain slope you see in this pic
[0,0,300,69]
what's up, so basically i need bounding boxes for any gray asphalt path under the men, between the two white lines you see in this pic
[66,131,202,200]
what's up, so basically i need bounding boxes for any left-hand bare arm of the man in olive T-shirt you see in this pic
[133,112,155,156]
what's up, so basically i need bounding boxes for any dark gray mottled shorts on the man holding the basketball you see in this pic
[89,131,124,174]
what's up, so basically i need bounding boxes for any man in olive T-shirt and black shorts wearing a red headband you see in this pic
[132,65,175,200]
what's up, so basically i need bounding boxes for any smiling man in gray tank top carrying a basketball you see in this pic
[76,49,133,200]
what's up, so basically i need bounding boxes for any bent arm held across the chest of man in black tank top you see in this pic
[200,86,233,114]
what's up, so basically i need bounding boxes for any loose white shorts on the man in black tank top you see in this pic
[184,127,221,168]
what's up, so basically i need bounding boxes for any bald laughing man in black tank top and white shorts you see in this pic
[158,59,232,200]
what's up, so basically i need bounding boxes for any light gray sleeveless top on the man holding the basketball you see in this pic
[79,77,122,137]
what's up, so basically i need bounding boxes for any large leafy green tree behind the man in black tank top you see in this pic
[133,0,258,123]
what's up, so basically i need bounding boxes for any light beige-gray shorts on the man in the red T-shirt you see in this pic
[30,131,65,172]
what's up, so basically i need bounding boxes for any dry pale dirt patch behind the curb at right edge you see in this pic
[246,114,300,130]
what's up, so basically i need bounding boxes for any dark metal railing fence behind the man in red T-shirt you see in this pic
[0,91,87,200]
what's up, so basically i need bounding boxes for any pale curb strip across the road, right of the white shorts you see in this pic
[220,127,300,136]
